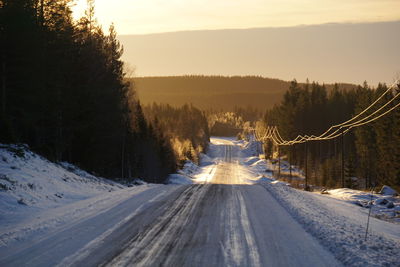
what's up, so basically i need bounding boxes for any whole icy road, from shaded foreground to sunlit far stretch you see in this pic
[0,139,340,267]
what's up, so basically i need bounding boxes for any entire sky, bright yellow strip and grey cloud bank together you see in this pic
[73,0,400,85]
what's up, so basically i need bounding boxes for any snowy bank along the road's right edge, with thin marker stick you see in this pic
[261,182,400,266]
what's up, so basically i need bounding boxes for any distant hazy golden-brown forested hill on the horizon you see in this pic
[133,76,355,111]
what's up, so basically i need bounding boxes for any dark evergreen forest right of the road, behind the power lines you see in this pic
[264,80,400,191]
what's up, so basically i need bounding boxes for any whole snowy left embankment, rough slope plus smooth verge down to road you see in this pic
[0,145,156,249]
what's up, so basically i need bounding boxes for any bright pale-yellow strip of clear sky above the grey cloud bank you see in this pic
[73,0,400,35]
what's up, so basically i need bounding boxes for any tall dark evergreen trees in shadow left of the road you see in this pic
[0,0,176,182]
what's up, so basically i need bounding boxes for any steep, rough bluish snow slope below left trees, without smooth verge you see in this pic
[0,145,124,226]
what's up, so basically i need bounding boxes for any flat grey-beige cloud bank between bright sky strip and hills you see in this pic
[119,21,400,86]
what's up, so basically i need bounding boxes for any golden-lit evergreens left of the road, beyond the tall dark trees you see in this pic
[143,103,210,166]
